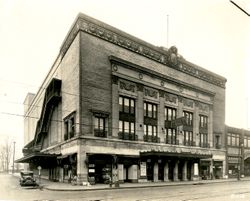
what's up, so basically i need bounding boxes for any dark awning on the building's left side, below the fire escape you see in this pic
[15,152,57,163]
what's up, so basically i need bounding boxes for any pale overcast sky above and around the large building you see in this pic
[0,0,250,156]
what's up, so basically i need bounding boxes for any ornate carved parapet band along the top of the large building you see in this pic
[60,13,226,88]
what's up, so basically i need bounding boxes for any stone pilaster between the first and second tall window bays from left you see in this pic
[135,84,144,141]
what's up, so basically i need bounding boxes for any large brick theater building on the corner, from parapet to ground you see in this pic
[17,14,227,183]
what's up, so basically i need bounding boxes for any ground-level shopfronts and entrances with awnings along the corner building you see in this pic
[18,151,225,184]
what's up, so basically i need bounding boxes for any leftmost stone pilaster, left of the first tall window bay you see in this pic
[109,75,119,138]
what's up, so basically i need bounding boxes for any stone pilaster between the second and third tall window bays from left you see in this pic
[157,91,166,143]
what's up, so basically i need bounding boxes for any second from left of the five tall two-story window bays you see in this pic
[144,102,158,142]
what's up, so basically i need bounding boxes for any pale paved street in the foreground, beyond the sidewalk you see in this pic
[0,174,250,201]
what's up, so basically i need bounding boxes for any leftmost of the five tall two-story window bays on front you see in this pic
[119,96,137,140]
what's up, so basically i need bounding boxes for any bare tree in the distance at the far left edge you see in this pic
[0,137,13,172]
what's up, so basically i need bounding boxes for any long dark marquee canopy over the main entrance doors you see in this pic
[140,150,212,159]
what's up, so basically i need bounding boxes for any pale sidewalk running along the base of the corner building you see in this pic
[13,174,250,191]
